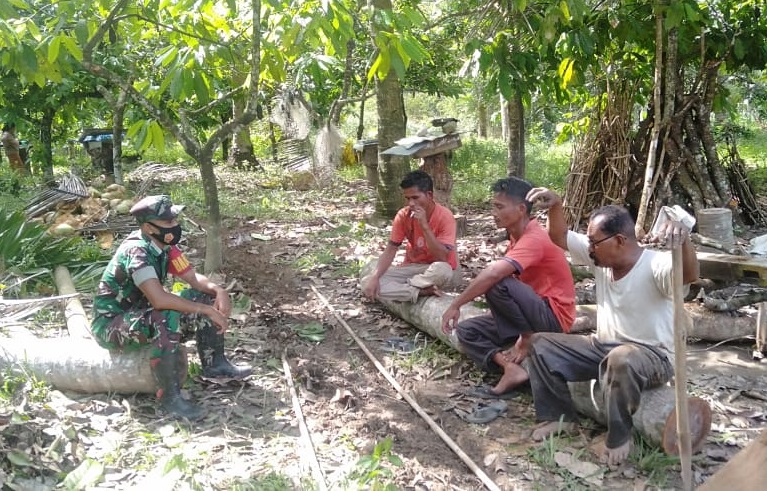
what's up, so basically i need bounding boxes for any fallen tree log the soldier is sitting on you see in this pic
[0,338,187,394]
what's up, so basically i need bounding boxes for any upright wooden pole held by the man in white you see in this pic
[671,245,693,491]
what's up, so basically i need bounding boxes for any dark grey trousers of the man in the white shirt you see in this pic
[527,334,674,448]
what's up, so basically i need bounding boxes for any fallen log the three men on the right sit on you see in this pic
[382,295,711,454]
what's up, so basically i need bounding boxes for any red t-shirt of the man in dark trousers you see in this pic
[504,219,575,332]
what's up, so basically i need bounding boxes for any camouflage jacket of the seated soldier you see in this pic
[93,230,170,326]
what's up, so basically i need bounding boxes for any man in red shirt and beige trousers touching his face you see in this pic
[360,170,458,302]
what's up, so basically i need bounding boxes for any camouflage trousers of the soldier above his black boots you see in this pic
[92,288,214,358]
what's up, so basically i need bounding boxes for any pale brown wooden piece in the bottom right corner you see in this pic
[698,430,767,491]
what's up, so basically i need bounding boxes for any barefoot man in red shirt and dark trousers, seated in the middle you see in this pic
[442,177,575,398]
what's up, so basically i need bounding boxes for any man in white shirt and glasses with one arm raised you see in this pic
[527,188,699,466]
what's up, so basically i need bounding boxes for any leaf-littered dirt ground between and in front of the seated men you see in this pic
[0,174,767,490]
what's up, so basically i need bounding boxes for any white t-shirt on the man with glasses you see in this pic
[567,231,674,357]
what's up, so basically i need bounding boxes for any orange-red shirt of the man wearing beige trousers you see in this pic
[389,203,458,269]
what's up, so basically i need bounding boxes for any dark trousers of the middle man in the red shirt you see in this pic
[456,278,562,372]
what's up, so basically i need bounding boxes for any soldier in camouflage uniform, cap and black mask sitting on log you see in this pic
[91,195,251,420]
